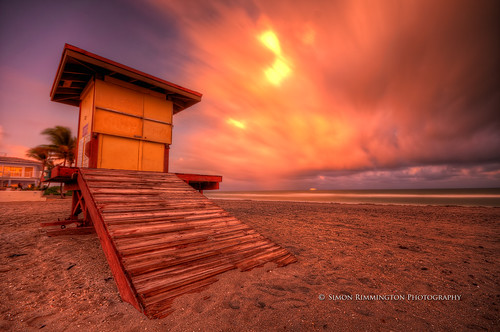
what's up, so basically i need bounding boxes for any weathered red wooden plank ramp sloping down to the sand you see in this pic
[78,168,296,318]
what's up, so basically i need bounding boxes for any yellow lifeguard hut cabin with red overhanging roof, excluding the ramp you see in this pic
[50,44,214,184]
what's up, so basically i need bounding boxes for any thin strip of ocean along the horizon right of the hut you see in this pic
[204,188,500,207]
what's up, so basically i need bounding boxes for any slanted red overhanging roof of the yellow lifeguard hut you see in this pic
[50,44,202,114]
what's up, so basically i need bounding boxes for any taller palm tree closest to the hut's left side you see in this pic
[42,126,76,166]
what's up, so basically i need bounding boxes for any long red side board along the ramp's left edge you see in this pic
[78,173,144,313]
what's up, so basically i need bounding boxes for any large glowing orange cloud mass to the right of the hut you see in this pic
[146,1,500,186]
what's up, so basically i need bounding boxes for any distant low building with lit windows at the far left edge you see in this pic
[0,156,42,188]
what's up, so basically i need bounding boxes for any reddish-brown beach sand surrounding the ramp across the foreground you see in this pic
[0,199,500,331]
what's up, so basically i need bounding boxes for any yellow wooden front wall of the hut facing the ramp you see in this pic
[80,78,173,172]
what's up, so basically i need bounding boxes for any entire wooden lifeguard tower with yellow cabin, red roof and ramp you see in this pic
[43,44,296,318]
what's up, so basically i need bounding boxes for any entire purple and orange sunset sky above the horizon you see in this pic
[0,0,500,190]
